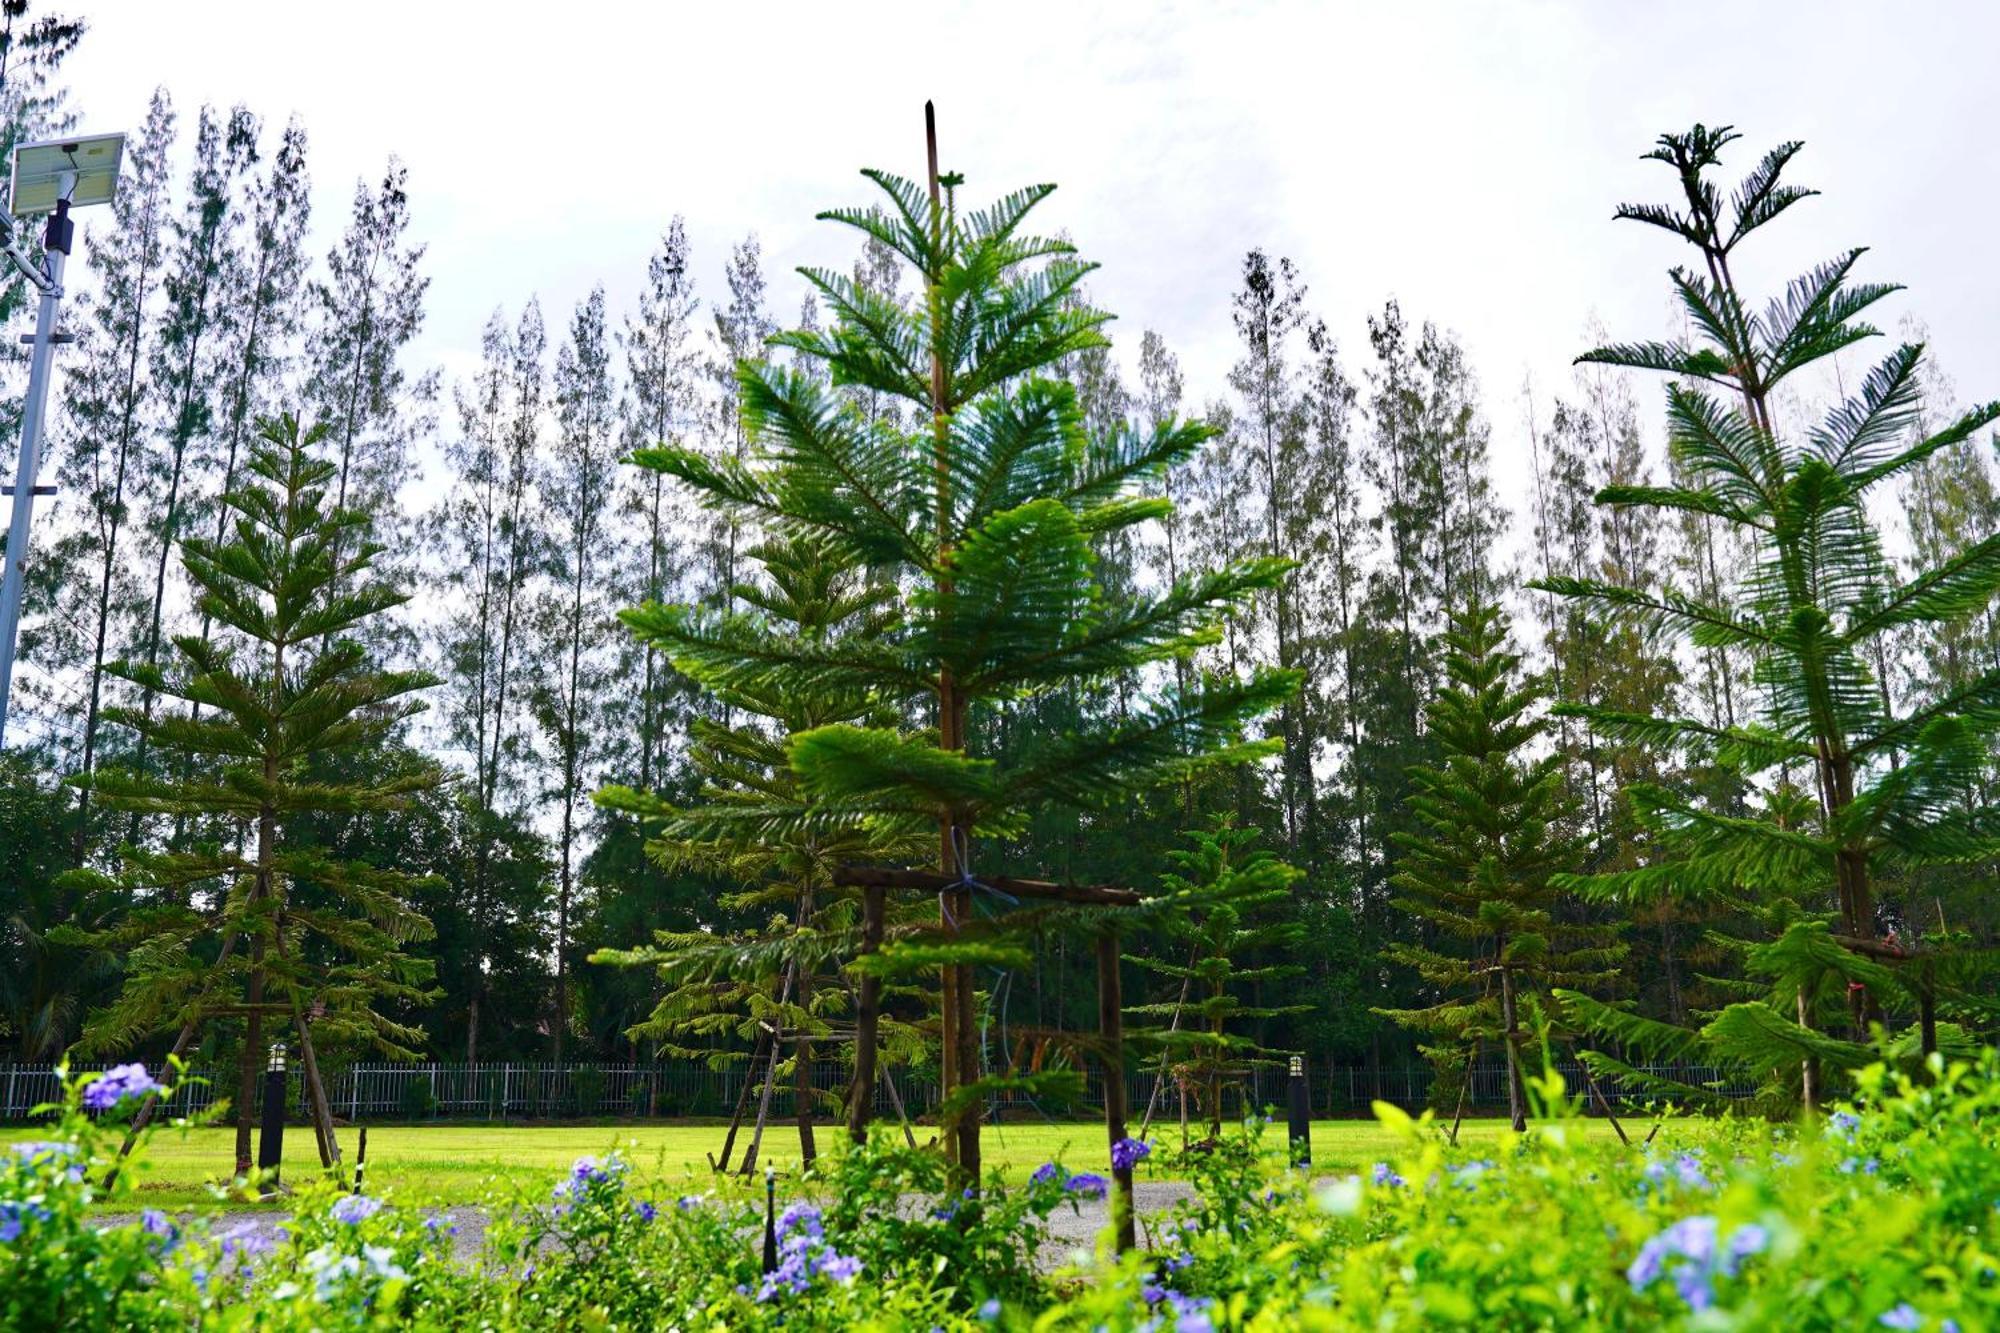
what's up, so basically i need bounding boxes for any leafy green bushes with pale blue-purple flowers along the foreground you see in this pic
[0,1055,2000,1333]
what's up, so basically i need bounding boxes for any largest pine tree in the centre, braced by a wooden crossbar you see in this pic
[630,122,1296,1181]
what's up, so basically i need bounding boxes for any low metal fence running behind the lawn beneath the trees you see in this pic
[0,1059,1754,1123]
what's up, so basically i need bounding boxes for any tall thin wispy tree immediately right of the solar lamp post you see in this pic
[52,90,174,865]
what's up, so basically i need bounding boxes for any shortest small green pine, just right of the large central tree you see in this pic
[1126,817,1308,1143]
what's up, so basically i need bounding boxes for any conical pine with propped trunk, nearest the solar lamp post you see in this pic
[62,416,438,1175]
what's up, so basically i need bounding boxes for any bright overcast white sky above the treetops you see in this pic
[54,0,2000,528]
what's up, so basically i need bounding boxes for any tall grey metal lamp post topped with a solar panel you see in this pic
[0,134,124,747]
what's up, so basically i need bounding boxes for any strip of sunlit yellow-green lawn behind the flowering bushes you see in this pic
[0,1121,1656,1209]
